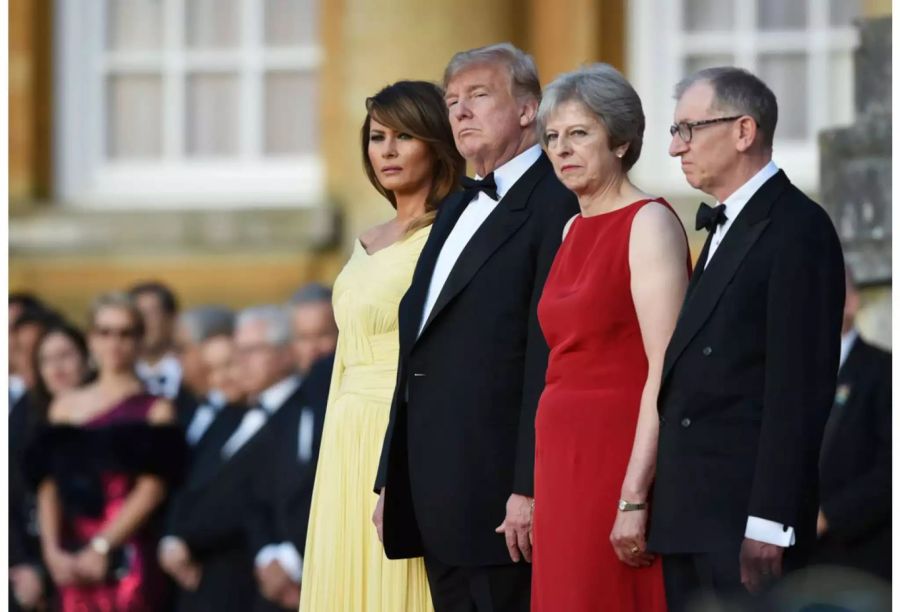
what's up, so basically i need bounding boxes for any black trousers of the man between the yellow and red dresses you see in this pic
[425,554,531,612]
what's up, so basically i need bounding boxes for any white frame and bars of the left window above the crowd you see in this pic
[54,0,325,209]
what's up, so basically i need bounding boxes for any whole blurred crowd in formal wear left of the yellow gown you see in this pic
[9,282,337,611]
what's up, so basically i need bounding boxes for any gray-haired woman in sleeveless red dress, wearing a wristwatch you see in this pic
[532,64,690,612]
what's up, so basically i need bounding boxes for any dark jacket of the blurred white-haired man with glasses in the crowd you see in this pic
[166,386,304,612]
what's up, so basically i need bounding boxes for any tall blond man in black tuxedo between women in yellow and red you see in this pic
[373,44,578,612]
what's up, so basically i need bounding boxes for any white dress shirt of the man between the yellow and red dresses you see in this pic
[419,145,541,334]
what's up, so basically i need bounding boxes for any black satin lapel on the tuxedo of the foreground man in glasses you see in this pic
[662,171,789,381]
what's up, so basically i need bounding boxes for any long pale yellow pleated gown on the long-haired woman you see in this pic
[300,227,433,612]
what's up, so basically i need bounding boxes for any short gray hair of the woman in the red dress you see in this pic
[536,64,644,172]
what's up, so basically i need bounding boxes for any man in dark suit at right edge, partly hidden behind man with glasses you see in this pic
[815,272,891,580]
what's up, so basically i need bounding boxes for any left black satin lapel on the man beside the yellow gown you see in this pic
[399,191,469,352]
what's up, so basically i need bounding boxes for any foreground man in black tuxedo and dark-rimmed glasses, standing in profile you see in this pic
[648,67,844,612]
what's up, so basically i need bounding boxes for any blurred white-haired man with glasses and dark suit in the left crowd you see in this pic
[159,306,306,612]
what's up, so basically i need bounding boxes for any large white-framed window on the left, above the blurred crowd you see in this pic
[55,0,323,207]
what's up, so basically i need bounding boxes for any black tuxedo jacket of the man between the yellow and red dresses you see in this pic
[375,154,578,566]
